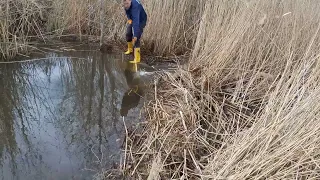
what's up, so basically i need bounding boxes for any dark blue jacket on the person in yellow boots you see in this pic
[126,0,147,39]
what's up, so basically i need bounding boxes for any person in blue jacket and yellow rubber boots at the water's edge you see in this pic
[123,0,147,63]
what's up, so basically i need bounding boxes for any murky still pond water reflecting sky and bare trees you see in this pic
[0,43,155,180]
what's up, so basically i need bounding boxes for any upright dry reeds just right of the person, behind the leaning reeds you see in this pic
[143,0,205,55]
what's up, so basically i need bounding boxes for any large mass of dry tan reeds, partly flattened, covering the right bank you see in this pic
[119,0,320,179]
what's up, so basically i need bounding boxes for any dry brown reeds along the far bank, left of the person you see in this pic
[0,0,126,59]
